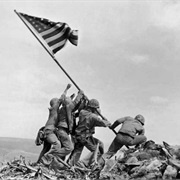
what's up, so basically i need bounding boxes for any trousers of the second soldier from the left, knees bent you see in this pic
[44,128,73,160]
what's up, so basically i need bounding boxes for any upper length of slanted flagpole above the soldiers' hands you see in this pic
[14,10,80,90]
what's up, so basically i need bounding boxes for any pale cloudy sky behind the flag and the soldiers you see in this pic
[0,0,180,148]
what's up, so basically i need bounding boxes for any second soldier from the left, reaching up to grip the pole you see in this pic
[44,90,83,162]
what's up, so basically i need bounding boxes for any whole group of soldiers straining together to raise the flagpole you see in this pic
[36,84,147,169]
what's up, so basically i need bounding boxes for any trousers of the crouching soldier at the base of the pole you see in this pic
[103,133,147,159]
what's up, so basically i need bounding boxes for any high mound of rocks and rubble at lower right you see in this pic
[100,140,180,180]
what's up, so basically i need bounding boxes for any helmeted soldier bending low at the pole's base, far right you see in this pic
[103,114,147,159]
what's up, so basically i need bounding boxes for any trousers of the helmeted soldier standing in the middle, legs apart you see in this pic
[68,136,104,166]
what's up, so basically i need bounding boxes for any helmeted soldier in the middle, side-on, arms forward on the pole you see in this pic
[68,99,111,166]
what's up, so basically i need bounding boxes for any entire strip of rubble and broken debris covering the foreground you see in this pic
[0,141,180,180]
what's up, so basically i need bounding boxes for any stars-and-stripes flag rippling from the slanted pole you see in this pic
[18,13,78,54]
